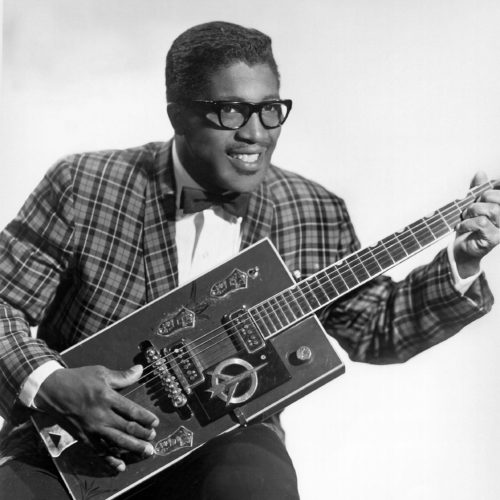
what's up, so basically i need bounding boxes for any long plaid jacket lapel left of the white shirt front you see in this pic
[143,141,178,302]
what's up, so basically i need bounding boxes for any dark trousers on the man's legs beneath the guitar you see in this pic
[0,424,299,500]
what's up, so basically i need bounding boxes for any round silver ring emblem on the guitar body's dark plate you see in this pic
[207,358,267,406]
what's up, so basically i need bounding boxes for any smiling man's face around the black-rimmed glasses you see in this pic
[172,62,281,192]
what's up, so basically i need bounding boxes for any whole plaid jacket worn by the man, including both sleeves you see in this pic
[0,143,492,426]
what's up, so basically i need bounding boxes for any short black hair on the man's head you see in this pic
[165,21,280,102]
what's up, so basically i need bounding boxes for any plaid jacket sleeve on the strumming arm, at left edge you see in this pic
[0,162,73,416]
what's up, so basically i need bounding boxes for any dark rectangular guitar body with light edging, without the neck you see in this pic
[34,240,344,500]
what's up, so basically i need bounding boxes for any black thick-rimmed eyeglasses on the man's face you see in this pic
[178,99,292,130]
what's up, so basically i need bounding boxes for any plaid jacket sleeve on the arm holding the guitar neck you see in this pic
[320,196,493,364]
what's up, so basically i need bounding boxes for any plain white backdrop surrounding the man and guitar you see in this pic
[0,0,500,500]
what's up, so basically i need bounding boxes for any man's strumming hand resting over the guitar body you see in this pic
[34,365,159,471]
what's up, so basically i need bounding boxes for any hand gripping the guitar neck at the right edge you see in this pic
[453,172,500,278]
